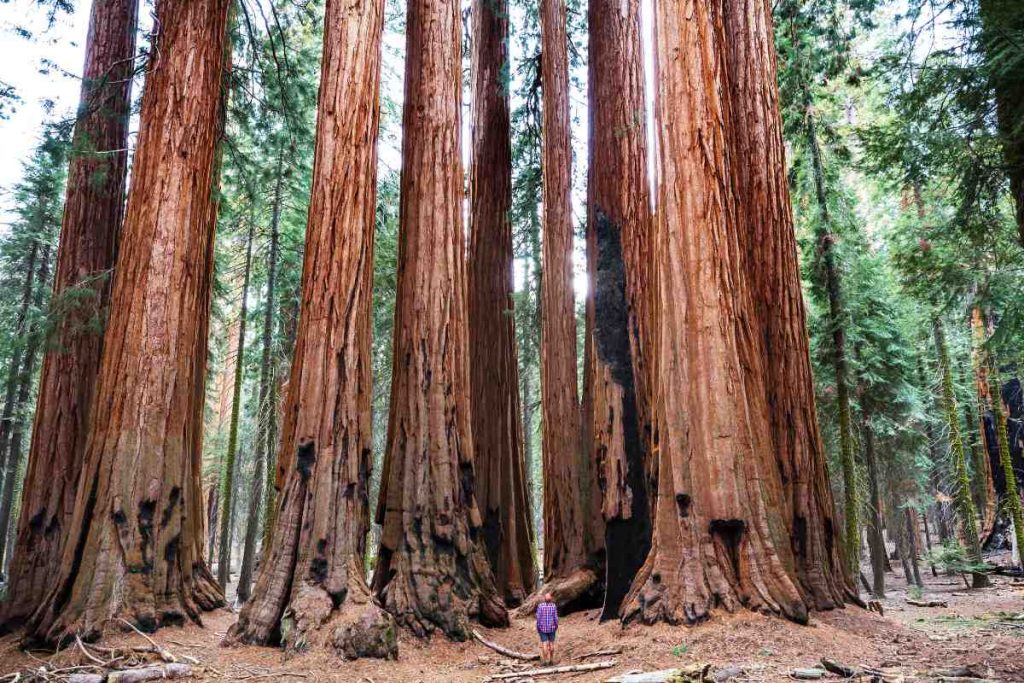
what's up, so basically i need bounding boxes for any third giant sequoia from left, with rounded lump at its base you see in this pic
[228,0,397,658]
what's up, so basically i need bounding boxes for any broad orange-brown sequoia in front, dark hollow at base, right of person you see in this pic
[623,0,808,624]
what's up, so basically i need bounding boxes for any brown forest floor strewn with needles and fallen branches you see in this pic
[0,558,1024,683]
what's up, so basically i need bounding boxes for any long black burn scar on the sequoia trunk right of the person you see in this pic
[594,208,651,621]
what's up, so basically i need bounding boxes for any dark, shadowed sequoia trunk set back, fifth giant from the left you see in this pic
[469,0,537,605]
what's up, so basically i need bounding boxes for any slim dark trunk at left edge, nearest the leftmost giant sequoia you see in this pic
[0,244,50,575]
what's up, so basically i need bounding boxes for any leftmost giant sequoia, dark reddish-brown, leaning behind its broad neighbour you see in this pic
[0,0,138,622]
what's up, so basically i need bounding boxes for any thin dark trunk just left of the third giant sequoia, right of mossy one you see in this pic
[238,152,285,602]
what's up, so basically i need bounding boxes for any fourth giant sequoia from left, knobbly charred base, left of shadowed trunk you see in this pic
[373,0,508,640]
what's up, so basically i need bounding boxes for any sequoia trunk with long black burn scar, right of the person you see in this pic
[585,0,653,618]
